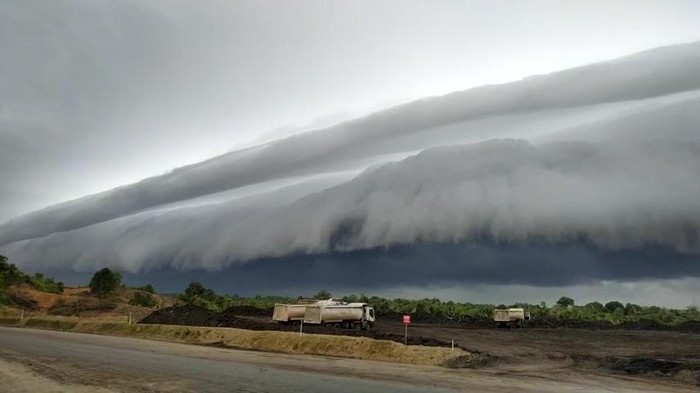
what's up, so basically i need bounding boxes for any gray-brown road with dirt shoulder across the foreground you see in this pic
[0,328,695,393]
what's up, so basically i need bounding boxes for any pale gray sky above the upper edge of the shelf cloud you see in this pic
[0,0,700,221]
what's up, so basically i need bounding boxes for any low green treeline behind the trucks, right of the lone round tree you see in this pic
[178,282,700,326]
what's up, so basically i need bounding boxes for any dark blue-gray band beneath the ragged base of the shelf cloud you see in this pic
[98,242,700,294]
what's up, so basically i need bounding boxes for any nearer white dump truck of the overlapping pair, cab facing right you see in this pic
[304,303,375,330]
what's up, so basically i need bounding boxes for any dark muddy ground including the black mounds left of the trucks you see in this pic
[141,306,700,386]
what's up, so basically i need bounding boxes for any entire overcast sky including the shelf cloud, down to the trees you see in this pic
[0,0,700,306]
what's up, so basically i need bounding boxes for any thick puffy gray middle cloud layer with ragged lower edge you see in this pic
[0,127,700,282]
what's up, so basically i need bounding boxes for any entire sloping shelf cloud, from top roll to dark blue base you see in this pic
[0,44,700,286]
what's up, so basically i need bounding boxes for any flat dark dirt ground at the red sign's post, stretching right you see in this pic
[379,324,700,386]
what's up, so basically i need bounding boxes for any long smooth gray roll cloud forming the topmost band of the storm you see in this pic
[0,43,700,244]
